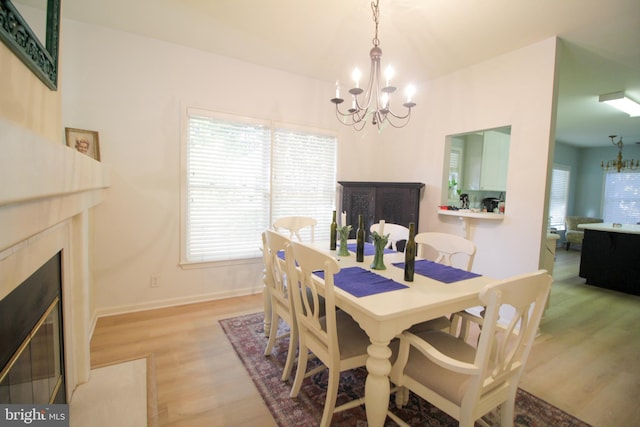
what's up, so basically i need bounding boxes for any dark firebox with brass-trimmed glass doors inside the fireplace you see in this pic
[0,252,67,404]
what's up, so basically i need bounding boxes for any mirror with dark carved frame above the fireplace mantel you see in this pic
[0,0,60,90]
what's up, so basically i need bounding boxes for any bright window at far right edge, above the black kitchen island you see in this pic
[602,172,640,224]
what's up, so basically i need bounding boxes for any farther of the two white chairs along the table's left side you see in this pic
[262,230,298,381]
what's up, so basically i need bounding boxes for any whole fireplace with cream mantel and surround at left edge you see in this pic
[0,117,110,403]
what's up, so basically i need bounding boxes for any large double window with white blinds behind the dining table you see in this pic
[181,109,337,264]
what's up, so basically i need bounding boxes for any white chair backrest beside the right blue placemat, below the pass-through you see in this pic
[415,232,476,271]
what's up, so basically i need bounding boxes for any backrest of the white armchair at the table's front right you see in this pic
[463,270,553,406]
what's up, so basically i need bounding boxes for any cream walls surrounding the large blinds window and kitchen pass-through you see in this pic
[61,20,555,313]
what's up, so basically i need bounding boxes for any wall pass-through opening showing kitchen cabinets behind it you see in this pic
[443,126,511,209]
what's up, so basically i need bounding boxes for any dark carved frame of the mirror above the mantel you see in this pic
[0,0,61,90]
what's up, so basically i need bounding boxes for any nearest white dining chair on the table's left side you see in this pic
[285,242,371,427]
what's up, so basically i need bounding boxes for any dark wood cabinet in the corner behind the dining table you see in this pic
[338,181,424,240]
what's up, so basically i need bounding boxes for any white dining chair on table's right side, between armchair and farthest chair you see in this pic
[410,232,476,337]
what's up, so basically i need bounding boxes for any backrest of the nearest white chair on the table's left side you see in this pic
[285,241,340,366]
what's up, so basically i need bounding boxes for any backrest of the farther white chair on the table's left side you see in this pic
[262,230,292,307]
